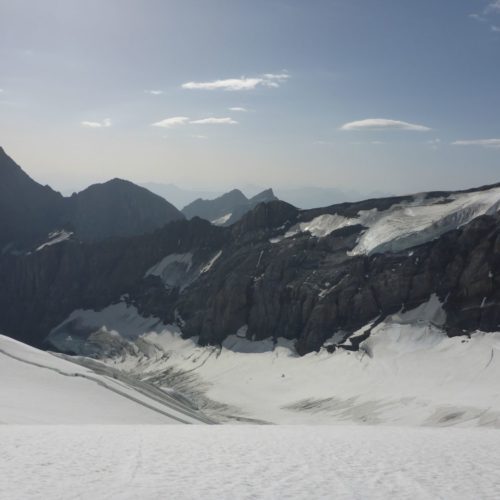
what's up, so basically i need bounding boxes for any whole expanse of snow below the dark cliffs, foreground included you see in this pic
[0,296,500,500]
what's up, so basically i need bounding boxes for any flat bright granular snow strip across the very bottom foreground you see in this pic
[0,426,500,500]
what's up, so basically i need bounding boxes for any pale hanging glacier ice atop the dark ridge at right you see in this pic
[285,187,500,255]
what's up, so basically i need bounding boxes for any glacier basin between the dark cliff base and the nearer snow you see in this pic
[49,296,500,427]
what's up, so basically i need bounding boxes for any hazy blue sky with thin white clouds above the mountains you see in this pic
[0,0,500,193]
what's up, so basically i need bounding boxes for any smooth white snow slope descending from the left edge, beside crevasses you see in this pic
[0,335,212,424]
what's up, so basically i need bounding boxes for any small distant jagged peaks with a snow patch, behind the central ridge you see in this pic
[182,189,278,226]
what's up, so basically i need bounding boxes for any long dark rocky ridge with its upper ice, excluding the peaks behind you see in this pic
[0,187,500,354]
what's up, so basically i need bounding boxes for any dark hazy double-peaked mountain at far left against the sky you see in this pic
[0,148,184,250]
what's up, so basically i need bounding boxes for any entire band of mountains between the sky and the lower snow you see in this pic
[0,146,500,372]
